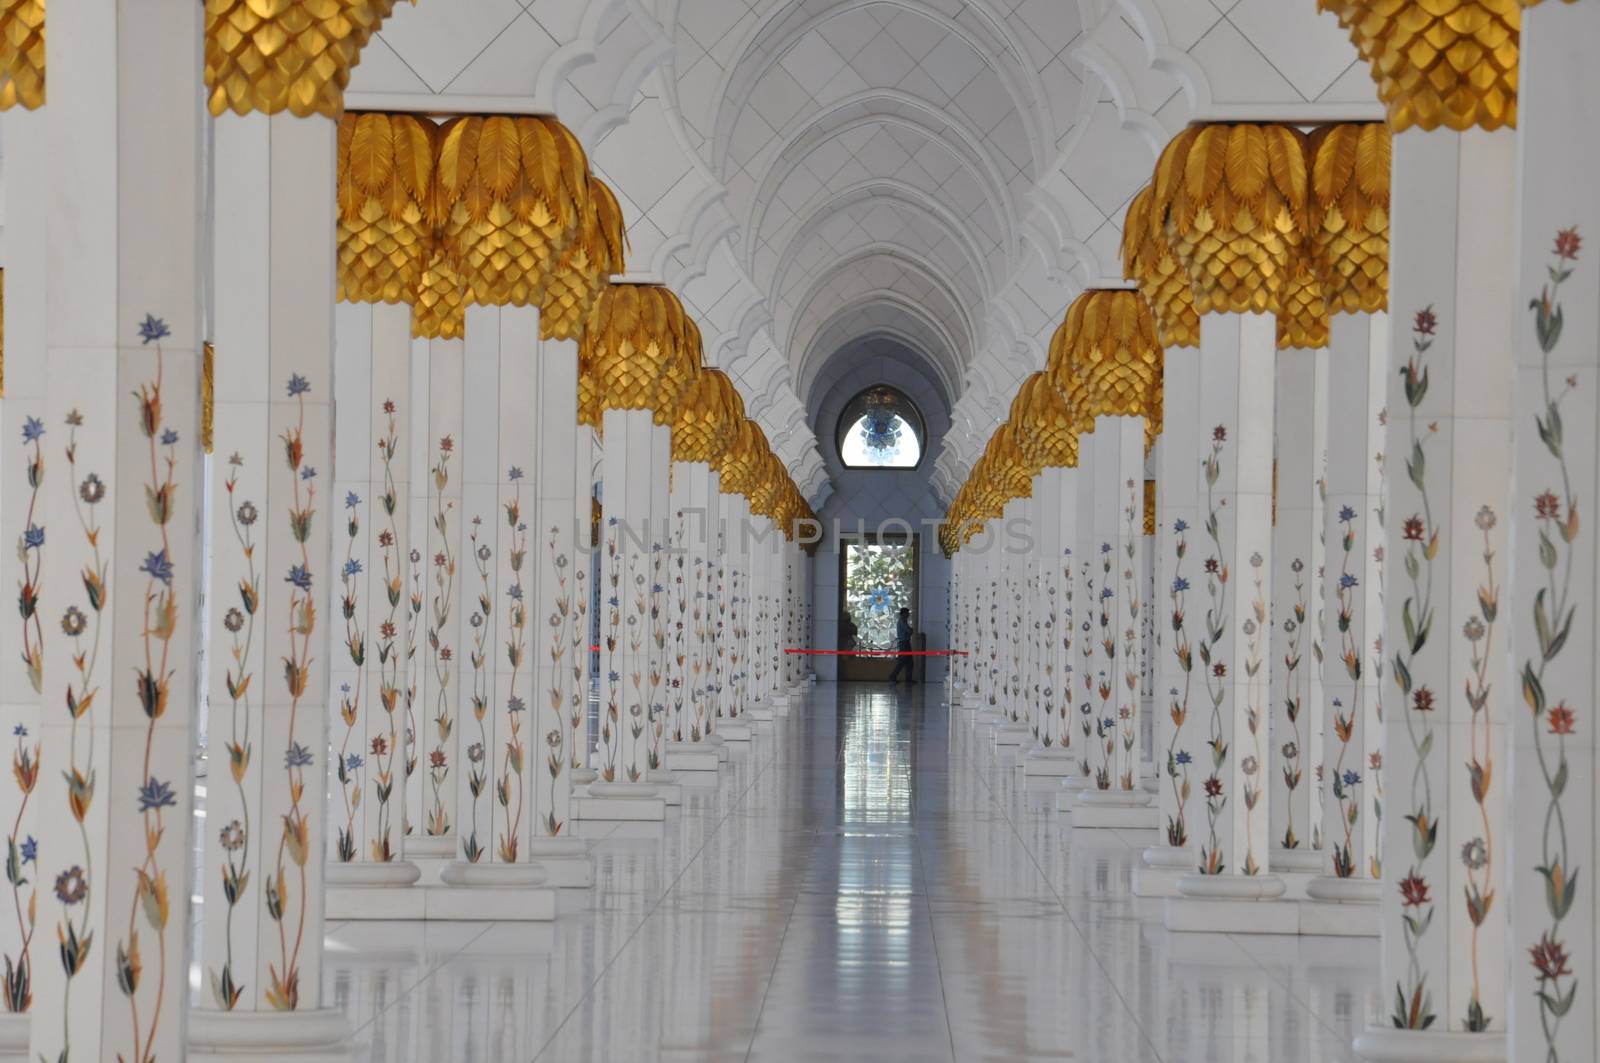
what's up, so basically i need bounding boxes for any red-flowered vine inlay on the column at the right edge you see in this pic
[1516,227,1594,1063]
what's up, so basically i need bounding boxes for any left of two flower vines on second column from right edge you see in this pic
[1390,307,1440,1029]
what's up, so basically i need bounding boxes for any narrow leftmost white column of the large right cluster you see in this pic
[1144,346,1205,869]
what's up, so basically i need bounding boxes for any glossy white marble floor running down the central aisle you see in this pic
[305,684,1378,1063]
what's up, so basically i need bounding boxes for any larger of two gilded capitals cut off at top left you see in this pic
[206,0,416,118]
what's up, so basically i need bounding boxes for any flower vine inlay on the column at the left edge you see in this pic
[5,416,45,1012]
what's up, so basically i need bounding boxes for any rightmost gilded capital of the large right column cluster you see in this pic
[1307,122,1392,314]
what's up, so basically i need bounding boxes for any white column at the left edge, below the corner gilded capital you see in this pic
[0,109,44,1058]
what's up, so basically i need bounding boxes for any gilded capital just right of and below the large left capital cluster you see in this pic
[578,285,697,429]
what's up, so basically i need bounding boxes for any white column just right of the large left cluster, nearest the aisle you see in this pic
[589,410,670,797]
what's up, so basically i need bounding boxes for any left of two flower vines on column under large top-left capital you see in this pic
[210,455,261,1012]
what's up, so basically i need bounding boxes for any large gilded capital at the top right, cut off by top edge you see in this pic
[1317,0,1516,133]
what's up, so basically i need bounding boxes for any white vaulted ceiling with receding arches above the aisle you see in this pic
[349,0,1379,504]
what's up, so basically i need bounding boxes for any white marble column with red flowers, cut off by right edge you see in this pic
[1510,3,1600,1061]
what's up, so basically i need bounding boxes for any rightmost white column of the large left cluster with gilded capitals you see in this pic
[523,339,594,868]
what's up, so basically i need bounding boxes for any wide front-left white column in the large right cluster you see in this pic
[1166,314,1294,909]
